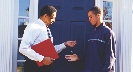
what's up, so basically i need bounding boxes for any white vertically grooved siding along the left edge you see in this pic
[0,0,17,72]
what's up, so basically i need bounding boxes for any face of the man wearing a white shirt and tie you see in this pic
[43,12,56,26]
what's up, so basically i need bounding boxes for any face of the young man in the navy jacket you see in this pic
[88,11,98,26]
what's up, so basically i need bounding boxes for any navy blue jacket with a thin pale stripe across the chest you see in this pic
[84,23,116,72]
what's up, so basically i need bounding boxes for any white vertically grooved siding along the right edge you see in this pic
[95,0,133,72]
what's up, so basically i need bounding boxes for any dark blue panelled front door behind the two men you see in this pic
[38,0,95,72]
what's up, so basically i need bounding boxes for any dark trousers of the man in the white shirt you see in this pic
[24,59,50,72]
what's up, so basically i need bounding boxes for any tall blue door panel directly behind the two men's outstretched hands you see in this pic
[70,21,86,55]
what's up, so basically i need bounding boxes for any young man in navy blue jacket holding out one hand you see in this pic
[66,6,116,72]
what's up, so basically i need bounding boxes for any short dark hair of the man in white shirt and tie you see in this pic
[40,5,57,16]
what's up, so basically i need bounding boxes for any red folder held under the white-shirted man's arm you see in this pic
[32,39,59,66]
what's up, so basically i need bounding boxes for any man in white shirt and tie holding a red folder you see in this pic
[19,5,76,72]
